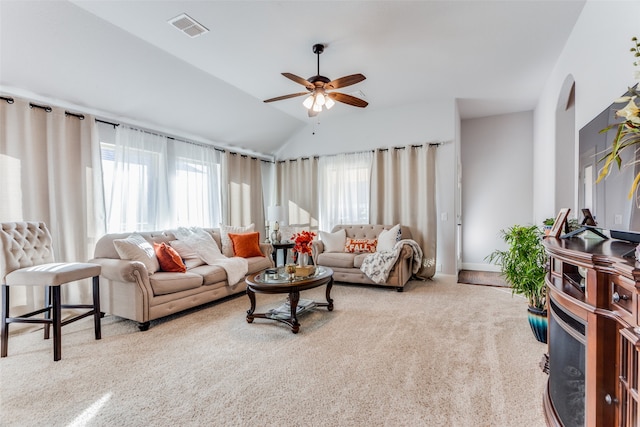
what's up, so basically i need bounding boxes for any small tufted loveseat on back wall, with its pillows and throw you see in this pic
[312,224,422,292]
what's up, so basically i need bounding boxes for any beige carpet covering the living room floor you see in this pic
[0,278,547,426]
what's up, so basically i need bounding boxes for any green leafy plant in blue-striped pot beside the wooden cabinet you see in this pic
[487,225,547,343]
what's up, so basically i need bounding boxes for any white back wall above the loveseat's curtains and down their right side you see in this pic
[276,98,459,274]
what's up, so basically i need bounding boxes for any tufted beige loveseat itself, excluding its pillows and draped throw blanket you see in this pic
[312,224,416,292]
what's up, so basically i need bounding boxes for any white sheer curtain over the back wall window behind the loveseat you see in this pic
[318,151,373,231]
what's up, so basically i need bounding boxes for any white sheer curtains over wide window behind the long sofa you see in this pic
[99,124,222,233]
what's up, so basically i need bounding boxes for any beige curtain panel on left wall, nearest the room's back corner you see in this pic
[222,152,265,234]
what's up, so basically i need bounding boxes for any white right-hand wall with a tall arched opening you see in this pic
[534,0,640,223]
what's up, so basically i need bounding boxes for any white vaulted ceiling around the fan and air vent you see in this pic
[0,0,584,154]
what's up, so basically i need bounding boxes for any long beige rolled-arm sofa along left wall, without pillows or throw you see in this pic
[90,229,273,331]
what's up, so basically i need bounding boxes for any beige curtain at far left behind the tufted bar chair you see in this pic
[0,95,104,329]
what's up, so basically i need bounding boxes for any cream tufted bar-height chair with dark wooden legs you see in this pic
[0,222,101,361]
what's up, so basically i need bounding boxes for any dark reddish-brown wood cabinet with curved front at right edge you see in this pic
[543,237,640,427]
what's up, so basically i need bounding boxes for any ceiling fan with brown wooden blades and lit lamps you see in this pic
[264,44,369,117]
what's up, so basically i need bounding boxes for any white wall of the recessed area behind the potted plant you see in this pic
[461,111,533,271]
